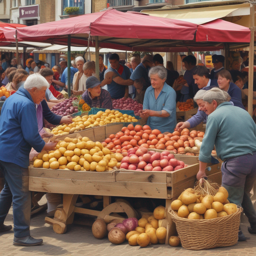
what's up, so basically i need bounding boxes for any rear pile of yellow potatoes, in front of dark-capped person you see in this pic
[52,109,138,135]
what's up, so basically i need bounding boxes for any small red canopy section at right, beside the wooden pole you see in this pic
[196,19,251,43]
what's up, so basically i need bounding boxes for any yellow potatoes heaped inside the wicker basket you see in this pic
[171,187,237,220]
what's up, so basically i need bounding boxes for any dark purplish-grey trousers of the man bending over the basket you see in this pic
[221,153,256,228]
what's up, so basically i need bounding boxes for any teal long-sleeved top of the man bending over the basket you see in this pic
[199,102,256,163]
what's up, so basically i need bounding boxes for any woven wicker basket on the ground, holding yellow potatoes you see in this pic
[169,207,243,250]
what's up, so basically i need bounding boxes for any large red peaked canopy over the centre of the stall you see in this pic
[2,9,197,49]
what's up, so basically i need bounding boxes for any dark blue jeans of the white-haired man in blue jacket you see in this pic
[0,161,31,238]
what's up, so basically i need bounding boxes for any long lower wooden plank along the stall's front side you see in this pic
[29,177,167,199]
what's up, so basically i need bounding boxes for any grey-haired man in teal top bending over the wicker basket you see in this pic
[197,88,256,241]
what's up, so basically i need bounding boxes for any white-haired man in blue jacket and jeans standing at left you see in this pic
[0,74,56,246]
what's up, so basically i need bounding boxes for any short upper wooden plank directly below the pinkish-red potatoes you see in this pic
[116,171,166,186]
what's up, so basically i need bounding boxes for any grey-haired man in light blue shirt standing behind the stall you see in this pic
[141,66,176,133]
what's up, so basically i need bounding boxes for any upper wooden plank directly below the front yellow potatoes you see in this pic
[29,167,115,182]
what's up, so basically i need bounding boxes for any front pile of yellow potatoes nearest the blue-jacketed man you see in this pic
[33,137,123,172]
